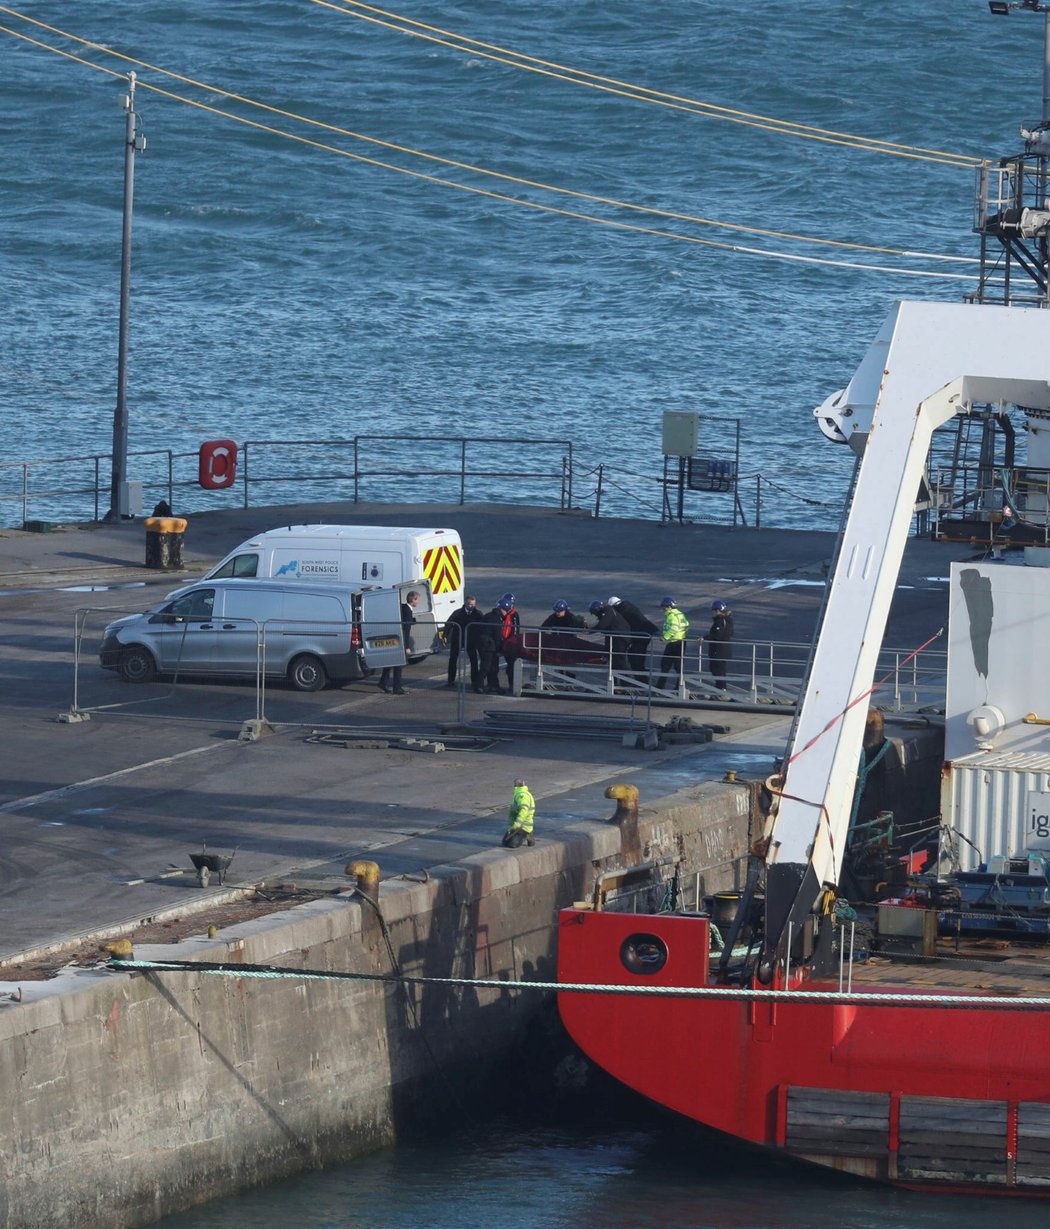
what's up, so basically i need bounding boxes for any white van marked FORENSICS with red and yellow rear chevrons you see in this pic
[204,525,464,627]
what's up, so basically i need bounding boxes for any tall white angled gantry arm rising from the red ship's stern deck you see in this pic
[766,302,1050,959]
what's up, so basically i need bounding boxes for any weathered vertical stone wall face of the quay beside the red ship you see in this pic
[0,783,755,1229]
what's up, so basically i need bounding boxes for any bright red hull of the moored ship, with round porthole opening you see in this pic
[558,909,1050,1195]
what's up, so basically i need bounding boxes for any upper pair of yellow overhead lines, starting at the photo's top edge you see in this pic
[310,0,981,168]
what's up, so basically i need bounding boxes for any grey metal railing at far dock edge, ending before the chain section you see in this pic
[0,435,574,526]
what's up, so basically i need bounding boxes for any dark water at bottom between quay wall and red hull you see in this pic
[160,1105,1046,1229]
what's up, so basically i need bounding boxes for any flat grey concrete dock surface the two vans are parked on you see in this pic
[0,504,976,981]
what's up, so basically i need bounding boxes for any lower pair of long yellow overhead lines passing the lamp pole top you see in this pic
[0,5,993,281]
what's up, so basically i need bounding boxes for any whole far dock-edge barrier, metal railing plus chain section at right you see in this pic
[0,435,865,528]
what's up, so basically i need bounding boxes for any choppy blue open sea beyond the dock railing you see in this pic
[0,0,1041,524]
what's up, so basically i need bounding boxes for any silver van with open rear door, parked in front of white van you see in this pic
[100,580,434,691]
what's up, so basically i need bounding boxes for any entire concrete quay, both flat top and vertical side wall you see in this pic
[0,505,969,1229]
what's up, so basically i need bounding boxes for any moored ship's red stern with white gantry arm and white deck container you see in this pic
[558,302,1050,1193]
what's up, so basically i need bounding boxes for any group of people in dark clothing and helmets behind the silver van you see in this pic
[445,592,733,696]
